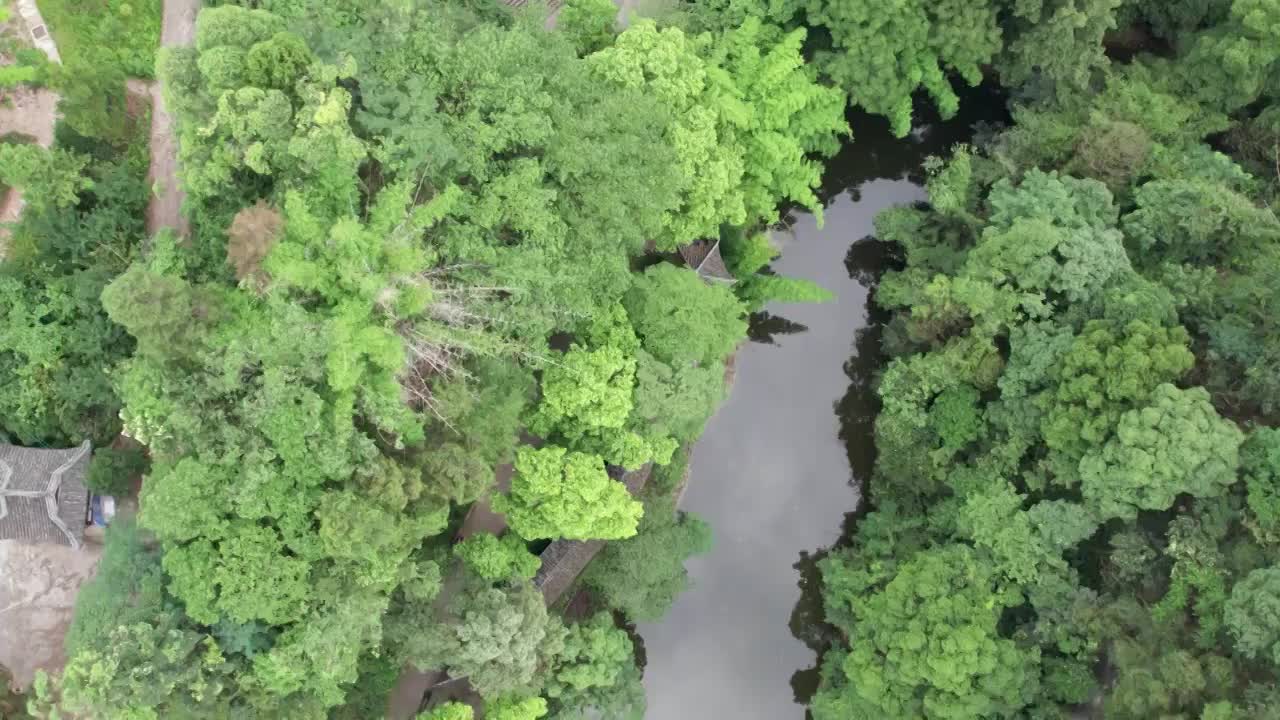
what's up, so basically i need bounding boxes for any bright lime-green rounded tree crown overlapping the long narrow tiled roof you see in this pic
[493,446,644,539]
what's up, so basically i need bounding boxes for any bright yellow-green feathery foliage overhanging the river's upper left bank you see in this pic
[588,18,847,243]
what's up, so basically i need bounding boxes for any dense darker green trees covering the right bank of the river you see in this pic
[814,47,1280,719]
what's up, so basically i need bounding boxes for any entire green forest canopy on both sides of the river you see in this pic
[0,0,1280,720]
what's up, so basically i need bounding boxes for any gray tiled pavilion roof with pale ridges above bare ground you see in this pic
[0,441,91,548]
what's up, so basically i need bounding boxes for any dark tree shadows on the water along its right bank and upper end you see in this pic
[778,86,1009,717]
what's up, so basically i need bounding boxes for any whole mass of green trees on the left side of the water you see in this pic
[30,0,829,717]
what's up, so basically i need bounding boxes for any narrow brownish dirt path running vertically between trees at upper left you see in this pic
[147,0,200,237]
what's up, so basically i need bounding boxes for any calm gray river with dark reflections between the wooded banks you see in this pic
[639,90,1005,720]
